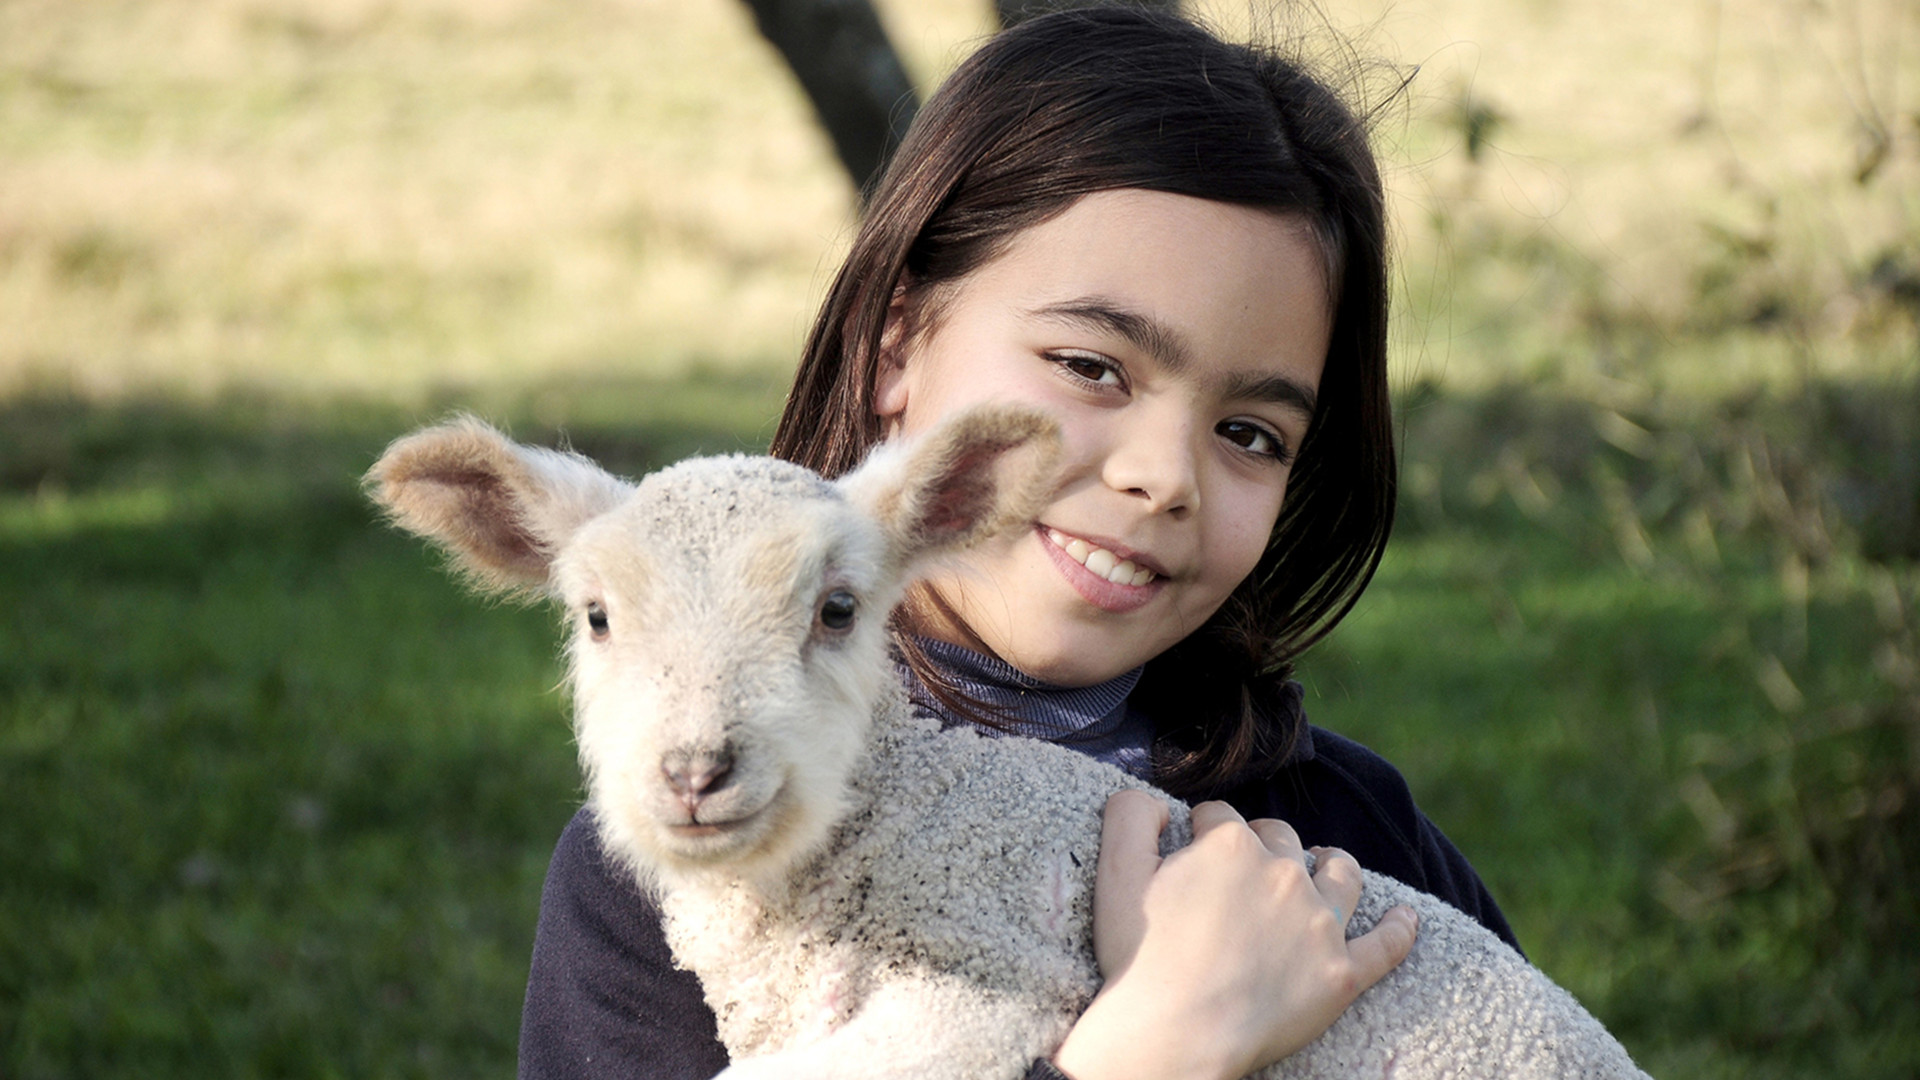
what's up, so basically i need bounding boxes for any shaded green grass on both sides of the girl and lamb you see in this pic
[0,377,1920,1080]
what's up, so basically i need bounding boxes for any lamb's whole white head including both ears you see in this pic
[369,407,1058,884]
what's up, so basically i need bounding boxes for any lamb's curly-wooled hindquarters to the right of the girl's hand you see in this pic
[1265,874,1645,1080]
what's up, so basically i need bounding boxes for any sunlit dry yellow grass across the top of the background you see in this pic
[0,0,1920,398]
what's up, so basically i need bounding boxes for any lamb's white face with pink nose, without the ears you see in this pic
[553,457,900,880]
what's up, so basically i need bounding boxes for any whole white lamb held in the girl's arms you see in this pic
[369,409,1642,1080]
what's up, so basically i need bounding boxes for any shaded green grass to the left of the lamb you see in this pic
[0,379,778,1080]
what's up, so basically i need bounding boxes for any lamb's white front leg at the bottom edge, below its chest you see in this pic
[720,974,1071,1080]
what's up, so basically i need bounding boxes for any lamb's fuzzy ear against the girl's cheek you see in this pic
[839,405,1060,567]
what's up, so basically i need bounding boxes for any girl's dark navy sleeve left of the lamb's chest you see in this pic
[520,809,728,1080]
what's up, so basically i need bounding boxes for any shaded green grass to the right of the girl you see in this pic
[1306,384,1920,1078]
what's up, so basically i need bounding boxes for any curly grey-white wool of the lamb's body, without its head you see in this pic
[662,680,1644,1080]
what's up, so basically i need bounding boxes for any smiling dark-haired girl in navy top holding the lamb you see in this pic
[520,8,1513,1080]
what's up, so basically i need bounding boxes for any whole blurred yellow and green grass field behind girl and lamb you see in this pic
[0,0,1920,1080]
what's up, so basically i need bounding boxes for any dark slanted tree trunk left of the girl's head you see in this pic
[747,0,920,202]
